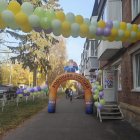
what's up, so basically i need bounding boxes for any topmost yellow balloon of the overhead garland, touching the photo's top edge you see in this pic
[8,0,21,14]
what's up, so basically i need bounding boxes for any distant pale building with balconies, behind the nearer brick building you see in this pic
[80,0,99,81]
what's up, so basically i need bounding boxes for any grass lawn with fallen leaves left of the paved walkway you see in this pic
[0,99,48,135]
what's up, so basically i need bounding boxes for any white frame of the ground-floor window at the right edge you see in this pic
[132,50,140,91]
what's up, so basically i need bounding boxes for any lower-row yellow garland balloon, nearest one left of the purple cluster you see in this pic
[80,24,89,37]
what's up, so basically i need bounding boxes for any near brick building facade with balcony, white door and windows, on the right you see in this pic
[81,0,140,129]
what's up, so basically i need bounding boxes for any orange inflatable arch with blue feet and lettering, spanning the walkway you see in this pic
[48,73,93,114]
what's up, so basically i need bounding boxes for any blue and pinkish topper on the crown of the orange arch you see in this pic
[64,59,78,72]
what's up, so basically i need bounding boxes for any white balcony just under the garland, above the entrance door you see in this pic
[98,41,122,60]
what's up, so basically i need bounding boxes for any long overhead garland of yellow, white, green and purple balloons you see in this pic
[0,0,140,42]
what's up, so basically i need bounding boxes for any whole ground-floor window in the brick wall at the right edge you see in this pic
[133,51,140,90]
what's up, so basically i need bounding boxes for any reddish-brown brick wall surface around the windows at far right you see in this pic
[118,0,140,130]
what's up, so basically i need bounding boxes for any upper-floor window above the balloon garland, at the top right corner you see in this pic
[131,0,140,19]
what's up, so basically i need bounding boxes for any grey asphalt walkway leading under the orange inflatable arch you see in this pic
[2,98,140,140]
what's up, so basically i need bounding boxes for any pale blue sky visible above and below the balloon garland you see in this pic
[59,0,94,65]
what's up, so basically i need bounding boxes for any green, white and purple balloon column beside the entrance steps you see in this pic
[92,70,105,110]
